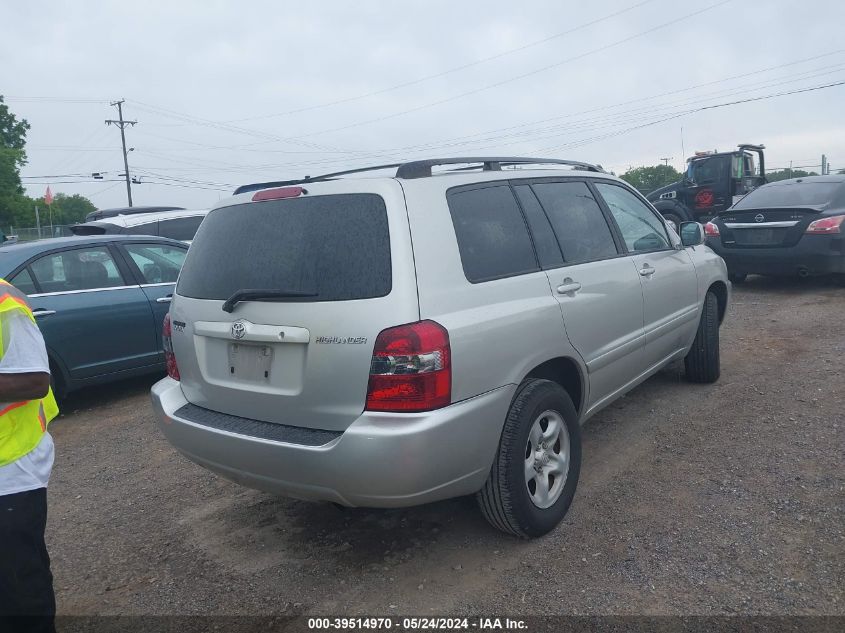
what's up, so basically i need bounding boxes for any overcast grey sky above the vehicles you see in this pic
[0,0,845,208]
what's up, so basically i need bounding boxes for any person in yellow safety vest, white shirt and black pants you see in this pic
[0,279,59,631]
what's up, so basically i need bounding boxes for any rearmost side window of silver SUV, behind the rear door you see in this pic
[448,185,539,283]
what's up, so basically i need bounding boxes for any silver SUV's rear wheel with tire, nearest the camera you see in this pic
[477,379,581,538]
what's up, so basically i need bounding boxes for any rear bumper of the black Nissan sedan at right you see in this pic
[707,235,845,275]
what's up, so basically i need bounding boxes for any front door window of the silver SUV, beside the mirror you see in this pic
[596,183,670,252]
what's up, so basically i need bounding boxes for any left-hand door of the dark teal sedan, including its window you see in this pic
[10,244,157,379]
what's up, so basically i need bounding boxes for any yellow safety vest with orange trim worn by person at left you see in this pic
[0,279,59,466]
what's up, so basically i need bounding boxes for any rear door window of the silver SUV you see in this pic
[531,182,618,264]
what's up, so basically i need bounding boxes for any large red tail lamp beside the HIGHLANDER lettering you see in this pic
[367,321,452,412]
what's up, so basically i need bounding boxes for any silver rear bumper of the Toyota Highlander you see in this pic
[152,378,515,507]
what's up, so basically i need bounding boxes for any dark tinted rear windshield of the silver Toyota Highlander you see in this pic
[177,194,392,302]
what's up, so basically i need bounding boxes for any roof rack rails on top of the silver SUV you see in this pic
[234,156,607,195]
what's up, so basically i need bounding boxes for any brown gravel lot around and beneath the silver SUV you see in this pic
[48,278,845,615]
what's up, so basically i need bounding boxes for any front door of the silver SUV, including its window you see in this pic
[594,182,699,367]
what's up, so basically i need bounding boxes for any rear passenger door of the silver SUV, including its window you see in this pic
[514,180,645,409]
